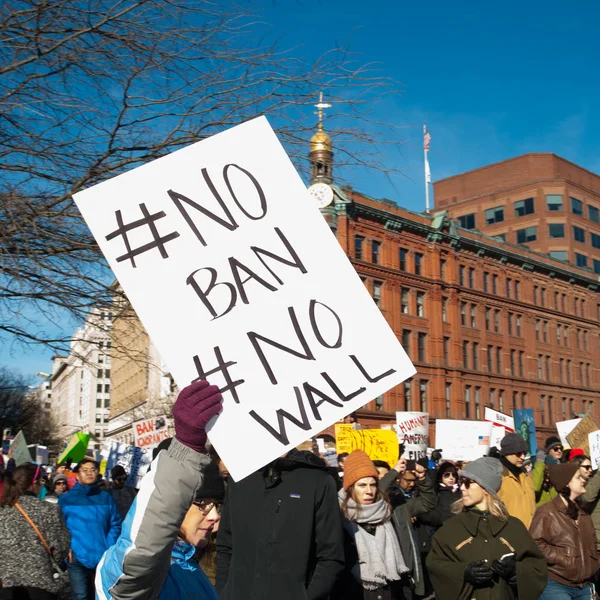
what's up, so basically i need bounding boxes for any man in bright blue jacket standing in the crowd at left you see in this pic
[58,458,122,600]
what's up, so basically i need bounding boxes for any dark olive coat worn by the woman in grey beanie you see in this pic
[427,510,548,600]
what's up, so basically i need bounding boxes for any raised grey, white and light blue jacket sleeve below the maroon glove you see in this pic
[96,439,210,600]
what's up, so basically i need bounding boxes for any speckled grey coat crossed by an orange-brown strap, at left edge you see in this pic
[0,496,71,594]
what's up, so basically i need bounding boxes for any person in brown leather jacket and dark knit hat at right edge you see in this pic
[530,463,598,600]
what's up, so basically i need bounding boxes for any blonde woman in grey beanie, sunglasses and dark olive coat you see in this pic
[427,457,548,600]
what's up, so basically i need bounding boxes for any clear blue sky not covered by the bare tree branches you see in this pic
[0,0,600,374]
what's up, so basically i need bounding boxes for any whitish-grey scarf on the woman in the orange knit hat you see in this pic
[340,490,408,590]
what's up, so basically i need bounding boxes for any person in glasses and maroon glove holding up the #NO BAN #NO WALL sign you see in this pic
[96,381,225,600]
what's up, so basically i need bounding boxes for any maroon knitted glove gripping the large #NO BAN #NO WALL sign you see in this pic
[173,381,223,452]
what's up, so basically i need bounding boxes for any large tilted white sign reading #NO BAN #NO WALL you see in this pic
[74,117,415,480]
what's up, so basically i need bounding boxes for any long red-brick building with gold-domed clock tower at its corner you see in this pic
[309,108,600,438]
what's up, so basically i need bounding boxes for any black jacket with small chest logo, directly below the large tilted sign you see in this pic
[216,450,344,600]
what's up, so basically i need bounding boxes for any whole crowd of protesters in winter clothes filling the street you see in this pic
[0,381,600,600]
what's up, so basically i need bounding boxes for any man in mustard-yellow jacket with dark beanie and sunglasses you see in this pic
[498,433,536,528]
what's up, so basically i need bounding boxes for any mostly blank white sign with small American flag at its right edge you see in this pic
[435,419,493,460]
